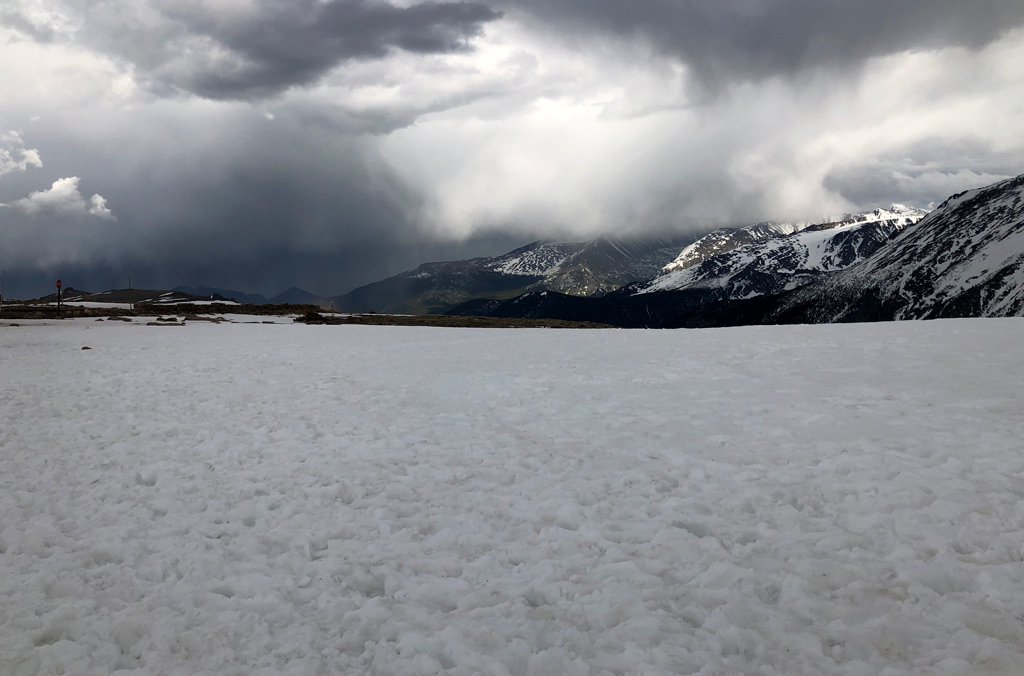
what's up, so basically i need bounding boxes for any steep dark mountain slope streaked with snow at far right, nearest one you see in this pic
[770,175,1024,322]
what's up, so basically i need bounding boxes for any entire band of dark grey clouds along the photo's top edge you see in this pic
[6,0,1024,105]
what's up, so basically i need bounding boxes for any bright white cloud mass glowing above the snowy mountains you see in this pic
[383,24,1024,237]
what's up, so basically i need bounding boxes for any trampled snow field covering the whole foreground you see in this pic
[0,320,1024,676]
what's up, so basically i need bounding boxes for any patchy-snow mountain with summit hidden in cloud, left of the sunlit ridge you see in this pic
[333,239,690,313]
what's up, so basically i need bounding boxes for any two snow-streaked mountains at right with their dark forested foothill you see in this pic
[451,176,1024,327]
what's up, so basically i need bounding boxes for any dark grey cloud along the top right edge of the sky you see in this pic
[498,0,1024,84]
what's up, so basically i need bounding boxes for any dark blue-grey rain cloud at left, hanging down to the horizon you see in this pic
[0,104,526,298]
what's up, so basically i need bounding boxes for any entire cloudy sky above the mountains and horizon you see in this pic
[0,0,1024,297]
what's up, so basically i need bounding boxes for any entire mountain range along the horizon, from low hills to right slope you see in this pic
[36,175,1024,328]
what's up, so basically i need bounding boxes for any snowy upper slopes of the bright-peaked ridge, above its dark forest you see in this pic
[630,204,928,298]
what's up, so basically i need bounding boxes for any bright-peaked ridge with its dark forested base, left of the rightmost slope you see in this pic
[451,205,942,327]
